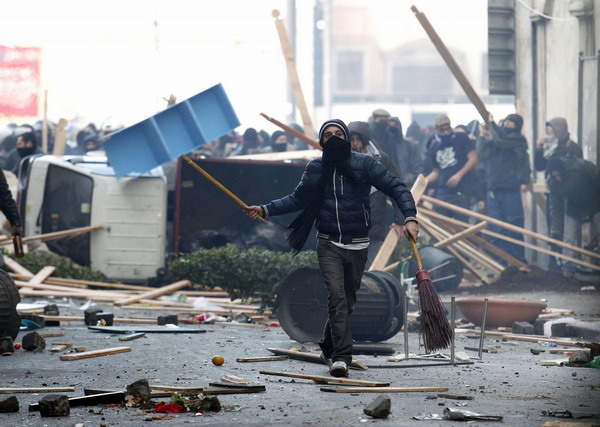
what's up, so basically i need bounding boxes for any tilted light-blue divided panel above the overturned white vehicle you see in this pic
[104,84,240,177]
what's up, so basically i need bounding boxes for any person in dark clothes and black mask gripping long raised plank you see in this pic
[477,114,531,263]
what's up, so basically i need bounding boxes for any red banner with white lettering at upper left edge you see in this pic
[0,46,41,117]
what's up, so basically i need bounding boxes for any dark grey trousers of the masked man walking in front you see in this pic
[317,240,367,364]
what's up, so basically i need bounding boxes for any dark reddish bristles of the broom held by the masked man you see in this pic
[418,280,452,352]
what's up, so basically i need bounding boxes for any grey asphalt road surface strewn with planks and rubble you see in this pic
[0,290,600,427]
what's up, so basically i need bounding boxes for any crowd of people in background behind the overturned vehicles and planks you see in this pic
[0,108,600,276]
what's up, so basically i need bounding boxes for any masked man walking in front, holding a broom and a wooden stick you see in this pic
[245,119,419,377]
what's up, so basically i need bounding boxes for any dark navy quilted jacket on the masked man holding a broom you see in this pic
[263,153,417,244]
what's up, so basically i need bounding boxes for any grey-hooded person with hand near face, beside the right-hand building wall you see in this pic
[534,117,583,270]
